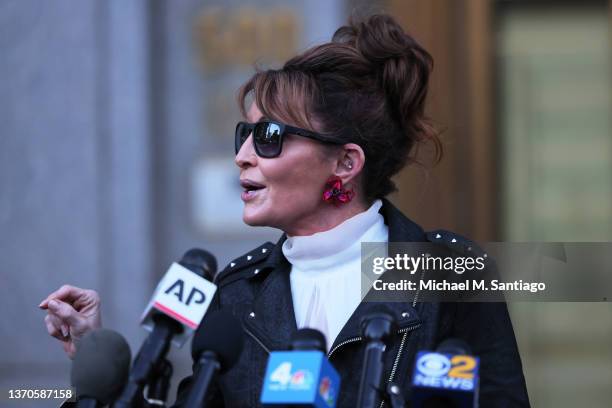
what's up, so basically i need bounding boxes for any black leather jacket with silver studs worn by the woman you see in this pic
[175,200,529,407]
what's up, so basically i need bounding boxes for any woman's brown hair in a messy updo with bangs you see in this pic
[238,15,442,202]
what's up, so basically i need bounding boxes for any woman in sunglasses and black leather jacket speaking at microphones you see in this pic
[42,15,529,407]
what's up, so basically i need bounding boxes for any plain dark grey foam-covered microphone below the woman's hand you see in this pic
[70,329,131,408]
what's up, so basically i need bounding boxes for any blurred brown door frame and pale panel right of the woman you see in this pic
[389,0,612,407]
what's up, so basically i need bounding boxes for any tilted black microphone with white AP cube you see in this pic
[114,249,217,407]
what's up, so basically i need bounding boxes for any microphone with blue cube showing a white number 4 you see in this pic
[261,329,340,408]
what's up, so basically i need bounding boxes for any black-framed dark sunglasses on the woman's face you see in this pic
[234,121,344,159]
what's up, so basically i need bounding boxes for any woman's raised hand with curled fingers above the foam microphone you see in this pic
[38,285,102,358]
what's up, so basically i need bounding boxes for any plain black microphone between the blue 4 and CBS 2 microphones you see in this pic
[357,306,397,408]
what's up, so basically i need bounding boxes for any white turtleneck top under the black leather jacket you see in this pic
[283,200,389,350]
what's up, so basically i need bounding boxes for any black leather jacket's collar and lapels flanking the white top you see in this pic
[245,199,426,350]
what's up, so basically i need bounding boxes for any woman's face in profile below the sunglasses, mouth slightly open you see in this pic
[235,103,336,235]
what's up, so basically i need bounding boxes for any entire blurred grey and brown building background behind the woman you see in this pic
[0,0,612,407]
